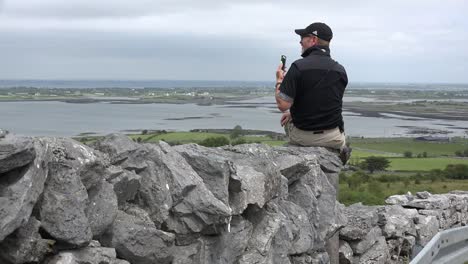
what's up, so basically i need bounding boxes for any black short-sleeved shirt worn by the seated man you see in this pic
[279,46,348,131]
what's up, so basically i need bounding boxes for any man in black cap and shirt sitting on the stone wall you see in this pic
[275,23,350,163]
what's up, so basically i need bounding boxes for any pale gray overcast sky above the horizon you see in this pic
[0,0,468,83]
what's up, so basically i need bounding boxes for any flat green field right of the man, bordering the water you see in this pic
[349,138,468,157]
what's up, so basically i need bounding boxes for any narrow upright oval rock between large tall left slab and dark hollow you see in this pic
[85,180,117,238]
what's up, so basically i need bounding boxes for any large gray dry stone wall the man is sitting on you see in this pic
[0,134,346,264]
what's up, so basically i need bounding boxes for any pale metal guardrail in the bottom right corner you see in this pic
[410,226,468,264]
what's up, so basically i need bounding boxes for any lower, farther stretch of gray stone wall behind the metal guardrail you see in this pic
[339,191,468,264]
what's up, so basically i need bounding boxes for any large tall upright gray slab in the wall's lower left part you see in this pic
[39,162,92,247]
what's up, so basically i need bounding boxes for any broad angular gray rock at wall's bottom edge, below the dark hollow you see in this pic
[100,209,175,264]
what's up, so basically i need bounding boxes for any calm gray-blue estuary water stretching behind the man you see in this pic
[0,97,468,137]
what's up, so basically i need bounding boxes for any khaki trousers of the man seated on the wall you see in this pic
[284,120,346,151]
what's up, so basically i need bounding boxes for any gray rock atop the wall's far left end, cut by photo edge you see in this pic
[0,137,36,175]
